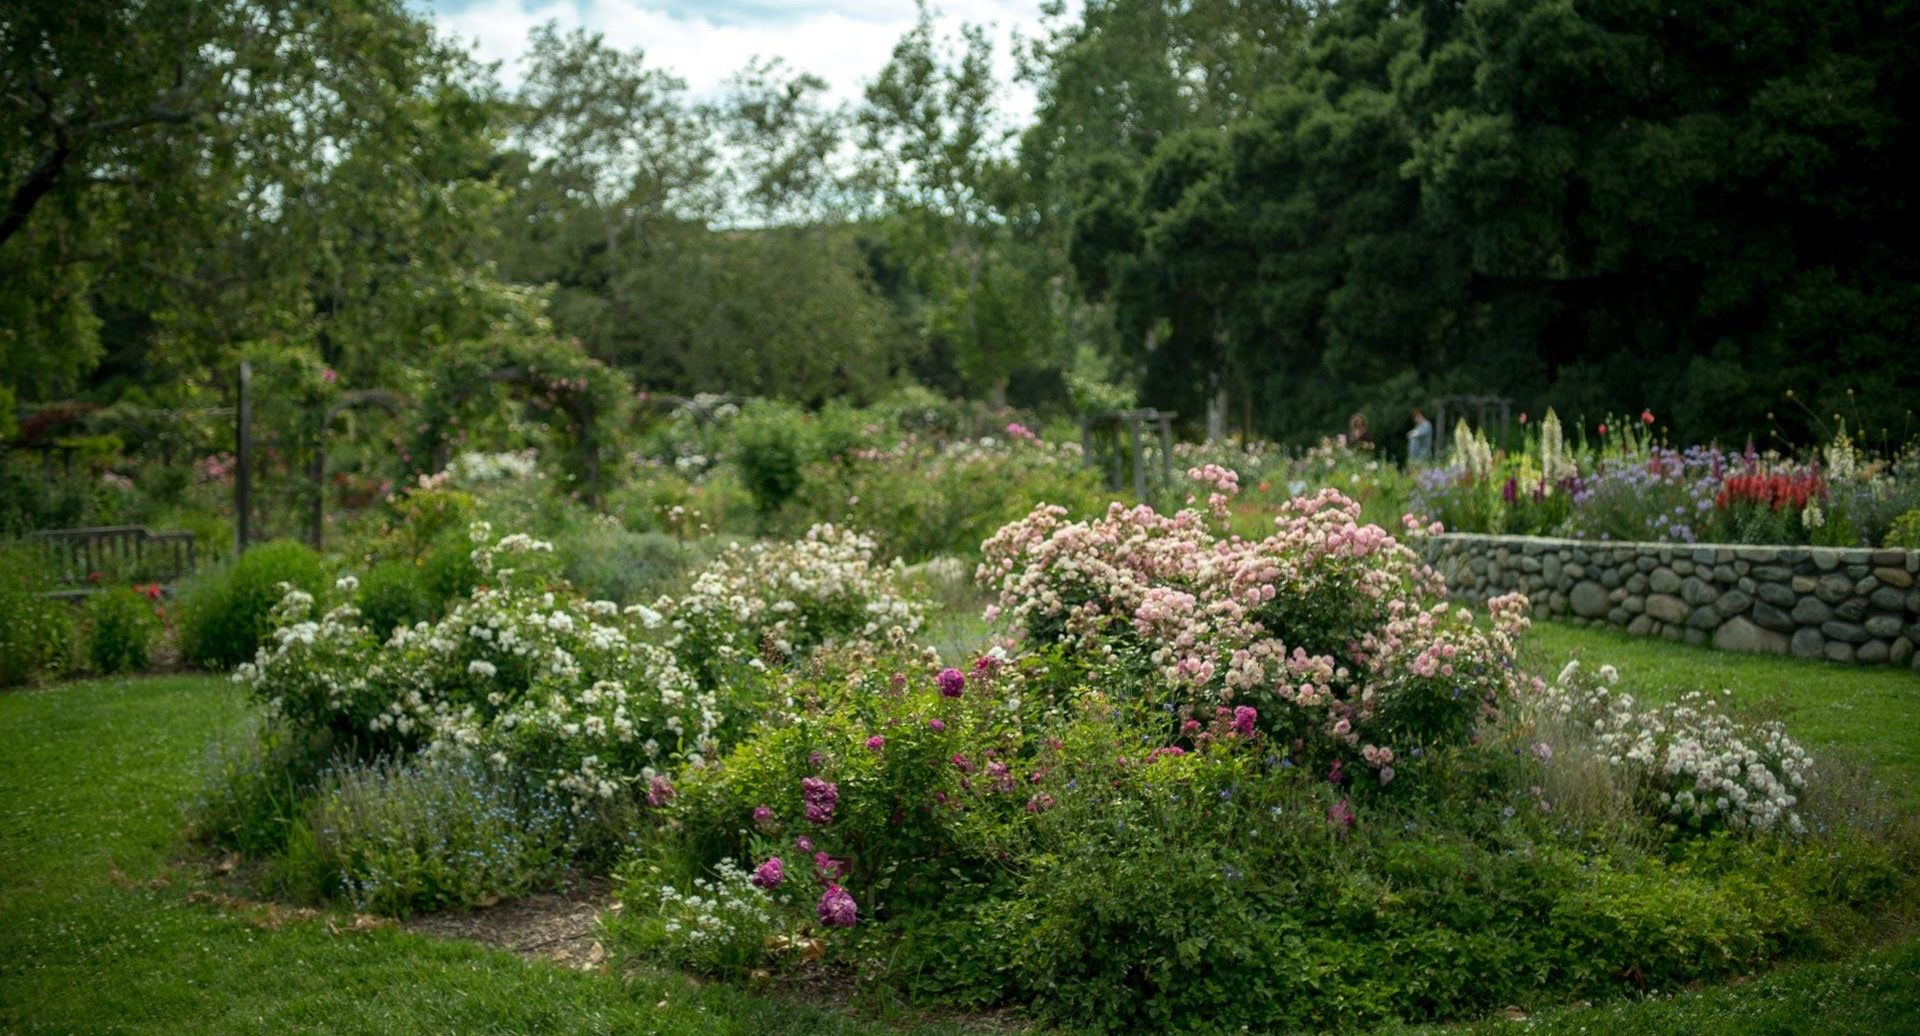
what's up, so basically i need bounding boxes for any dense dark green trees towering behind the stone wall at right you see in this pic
[1071,0,1920,437]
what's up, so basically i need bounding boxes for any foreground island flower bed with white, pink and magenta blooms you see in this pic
[187,491,1912,1030]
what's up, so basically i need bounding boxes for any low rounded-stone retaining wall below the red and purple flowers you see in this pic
[1423,533,1920,671]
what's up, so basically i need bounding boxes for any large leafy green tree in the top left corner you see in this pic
[0,0,497,395]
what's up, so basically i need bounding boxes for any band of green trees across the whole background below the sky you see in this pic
[0,0,1920,439]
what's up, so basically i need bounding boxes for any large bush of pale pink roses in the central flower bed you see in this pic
[977,494,1528,783]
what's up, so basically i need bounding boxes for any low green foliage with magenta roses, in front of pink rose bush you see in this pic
[648,640,1910,1032]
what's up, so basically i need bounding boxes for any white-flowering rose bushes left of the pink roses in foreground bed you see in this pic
[232,522,920,810]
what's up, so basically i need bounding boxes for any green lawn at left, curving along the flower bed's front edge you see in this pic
[0,677,975,1034]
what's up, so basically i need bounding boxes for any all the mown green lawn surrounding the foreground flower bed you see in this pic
[0,625,1920,1036]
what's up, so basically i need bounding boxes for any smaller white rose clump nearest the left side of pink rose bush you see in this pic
[655,526,922,677]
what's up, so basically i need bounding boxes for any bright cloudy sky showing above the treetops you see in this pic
[411,0,1067,119]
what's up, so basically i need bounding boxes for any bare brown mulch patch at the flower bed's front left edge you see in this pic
[401,877,612,971]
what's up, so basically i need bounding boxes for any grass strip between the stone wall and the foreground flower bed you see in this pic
[1523,624,1920,810]
